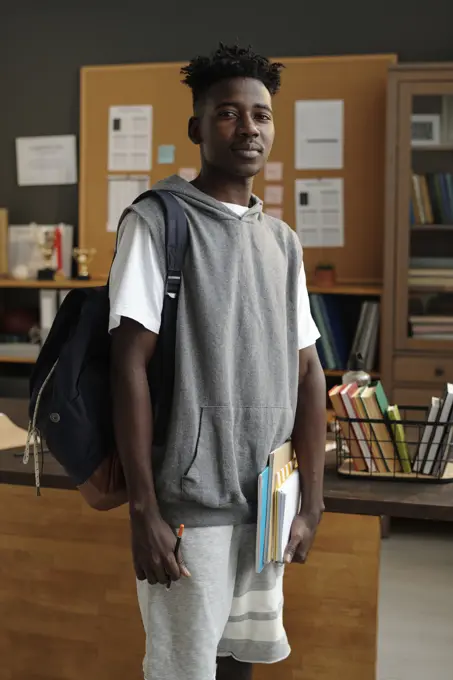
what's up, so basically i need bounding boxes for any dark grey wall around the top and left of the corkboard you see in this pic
[0,0,453,224]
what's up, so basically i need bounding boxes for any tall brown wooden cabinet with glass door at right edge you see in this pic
[381,63,453,406]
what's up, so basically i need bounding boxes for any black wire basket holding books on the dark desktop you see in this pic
[335,406,453,483]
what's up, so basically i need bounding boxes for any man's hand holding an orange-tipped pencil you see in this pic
[131,510,190,585]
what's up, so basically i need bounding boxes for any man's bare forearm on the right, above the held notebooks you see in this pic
[292,356,326,514]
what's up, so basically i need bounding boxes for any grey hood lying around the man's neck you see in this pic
[153,175,263,222]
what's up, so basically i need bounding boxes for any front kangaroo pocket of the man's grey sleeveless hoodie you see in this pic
[182,406,292,508]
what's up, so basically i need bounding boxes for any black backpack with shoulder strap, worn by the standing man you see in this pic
[24,190,188,510]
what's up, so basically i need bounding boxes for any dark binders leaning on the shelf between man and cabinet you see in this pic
[310,293,379,371]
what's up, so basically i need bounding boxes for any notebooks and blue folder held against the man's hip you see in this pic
[256,442,301,574]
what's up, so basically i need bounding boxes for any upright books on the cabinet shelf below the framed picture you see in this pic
[410,172,453,225]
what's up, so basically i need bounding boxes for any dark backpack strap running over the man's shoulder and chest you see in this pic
[134,189,189,444]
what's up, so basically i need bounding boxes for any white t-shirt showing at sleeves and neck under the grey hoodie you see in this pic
[109,203,319,349]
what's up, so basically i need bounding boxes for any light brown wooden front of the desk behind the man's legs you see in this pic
[0,485,380,680]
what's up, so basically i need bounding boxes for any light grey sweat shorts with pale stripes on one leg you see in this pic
[137,525,290,680]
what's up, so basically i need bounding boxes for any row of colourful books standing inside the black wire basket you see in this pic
[329,382,453,477]
